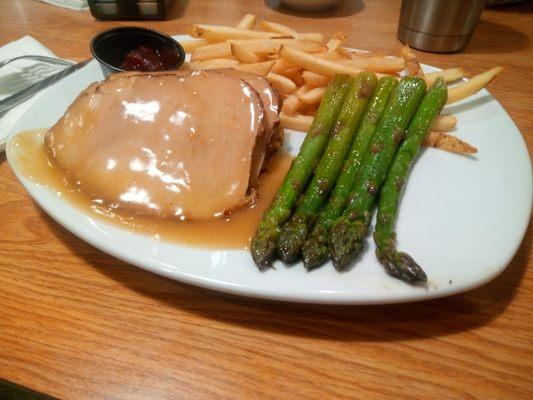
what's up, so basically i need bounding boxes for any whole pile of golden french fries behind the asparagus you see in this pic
[181,14,502,153]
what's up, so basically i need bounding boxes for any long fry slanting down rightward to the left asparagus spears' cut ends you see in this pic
[279,46,361,77]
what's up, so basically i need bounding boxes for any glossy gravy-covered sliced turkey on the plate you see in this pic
[46,71,271,219]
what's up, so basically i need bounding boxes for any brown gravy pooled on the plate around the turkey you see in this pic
[10,129,292,249]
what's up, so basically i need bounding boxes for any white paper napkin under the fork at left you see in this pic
[0,36,64,151]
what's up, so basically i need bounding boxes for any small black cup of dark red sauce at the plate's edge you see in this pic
[91,27,185,76]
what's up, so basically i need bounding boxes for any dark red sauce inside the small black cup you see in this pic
[120,45,178,71]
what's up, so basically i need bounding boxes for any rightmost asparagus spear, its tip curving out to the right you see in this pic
[374,78,448,282]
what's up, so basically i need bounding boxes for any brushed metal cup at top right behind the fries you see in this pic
[398,0,485,53]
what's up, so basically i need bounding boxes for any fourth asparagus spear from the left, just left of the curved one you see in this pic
[328,77,426,270]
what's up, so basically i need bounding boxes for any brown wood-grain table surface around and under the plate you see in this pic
[0,0,533,399]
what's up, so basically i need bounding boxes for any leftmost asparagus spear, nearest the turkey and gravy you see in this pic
[250,75,350,269]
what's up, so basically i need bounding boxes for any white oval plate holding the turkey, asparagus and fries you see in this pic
[7,37,532,304]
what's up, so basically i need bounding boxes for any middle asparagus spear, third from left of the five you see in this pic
[302,77,398,270]
